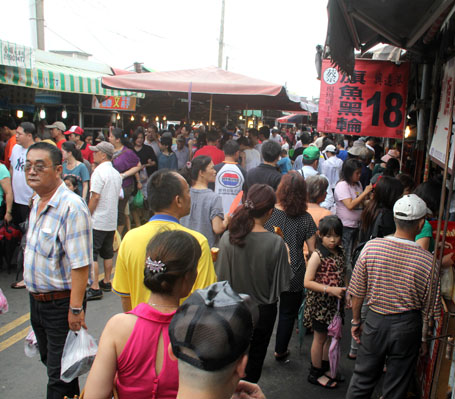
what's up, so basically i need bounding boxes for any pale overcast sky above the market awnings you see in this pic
[0,0,327,98]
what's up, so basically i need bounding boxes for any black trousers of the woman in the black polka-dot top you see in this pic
[275,291,303,355]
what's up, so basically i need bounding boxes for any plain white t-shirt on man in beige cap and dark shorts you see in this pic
[90,162,122,231]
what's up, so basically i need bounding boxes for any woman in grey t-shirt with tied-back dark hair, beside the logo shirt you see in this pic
[180,155,229,248]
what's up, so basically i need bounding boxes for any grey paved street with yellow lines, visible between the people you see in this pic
[0,260,370,399]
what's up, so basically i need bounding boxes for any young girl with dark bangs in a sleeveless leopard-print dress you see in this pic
[304,215,346,389]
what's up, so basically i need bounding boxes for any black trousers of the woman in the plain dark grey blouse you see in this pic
[244,303,277,383]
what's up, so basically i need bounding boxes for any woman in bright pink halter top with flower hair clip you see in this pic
[85,230,201,399]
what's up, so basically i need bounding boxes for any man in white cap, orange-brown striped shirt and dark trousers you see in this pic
[346,194,440,399]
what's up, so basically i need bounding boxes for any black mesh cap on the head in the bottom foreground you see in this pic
[169,281,258,371]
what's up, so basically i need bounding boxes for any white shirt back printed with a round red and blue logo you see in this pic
[215,163,245,215]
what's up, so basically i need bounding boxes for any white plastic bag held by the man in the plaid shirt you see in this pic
[60,328,98,382]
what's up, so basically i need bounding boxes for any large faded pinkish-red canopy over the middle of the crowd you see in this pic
[102,67,303,111]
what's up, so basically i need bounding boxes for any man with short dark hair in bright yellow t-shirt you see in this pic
[112,169,217,312]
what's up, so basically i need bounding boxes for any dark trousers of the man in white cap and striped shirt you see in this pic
[346,309,422,399]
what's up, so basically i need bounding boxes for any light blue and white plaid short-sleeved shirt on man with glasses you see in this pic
[24,182,93,292]
